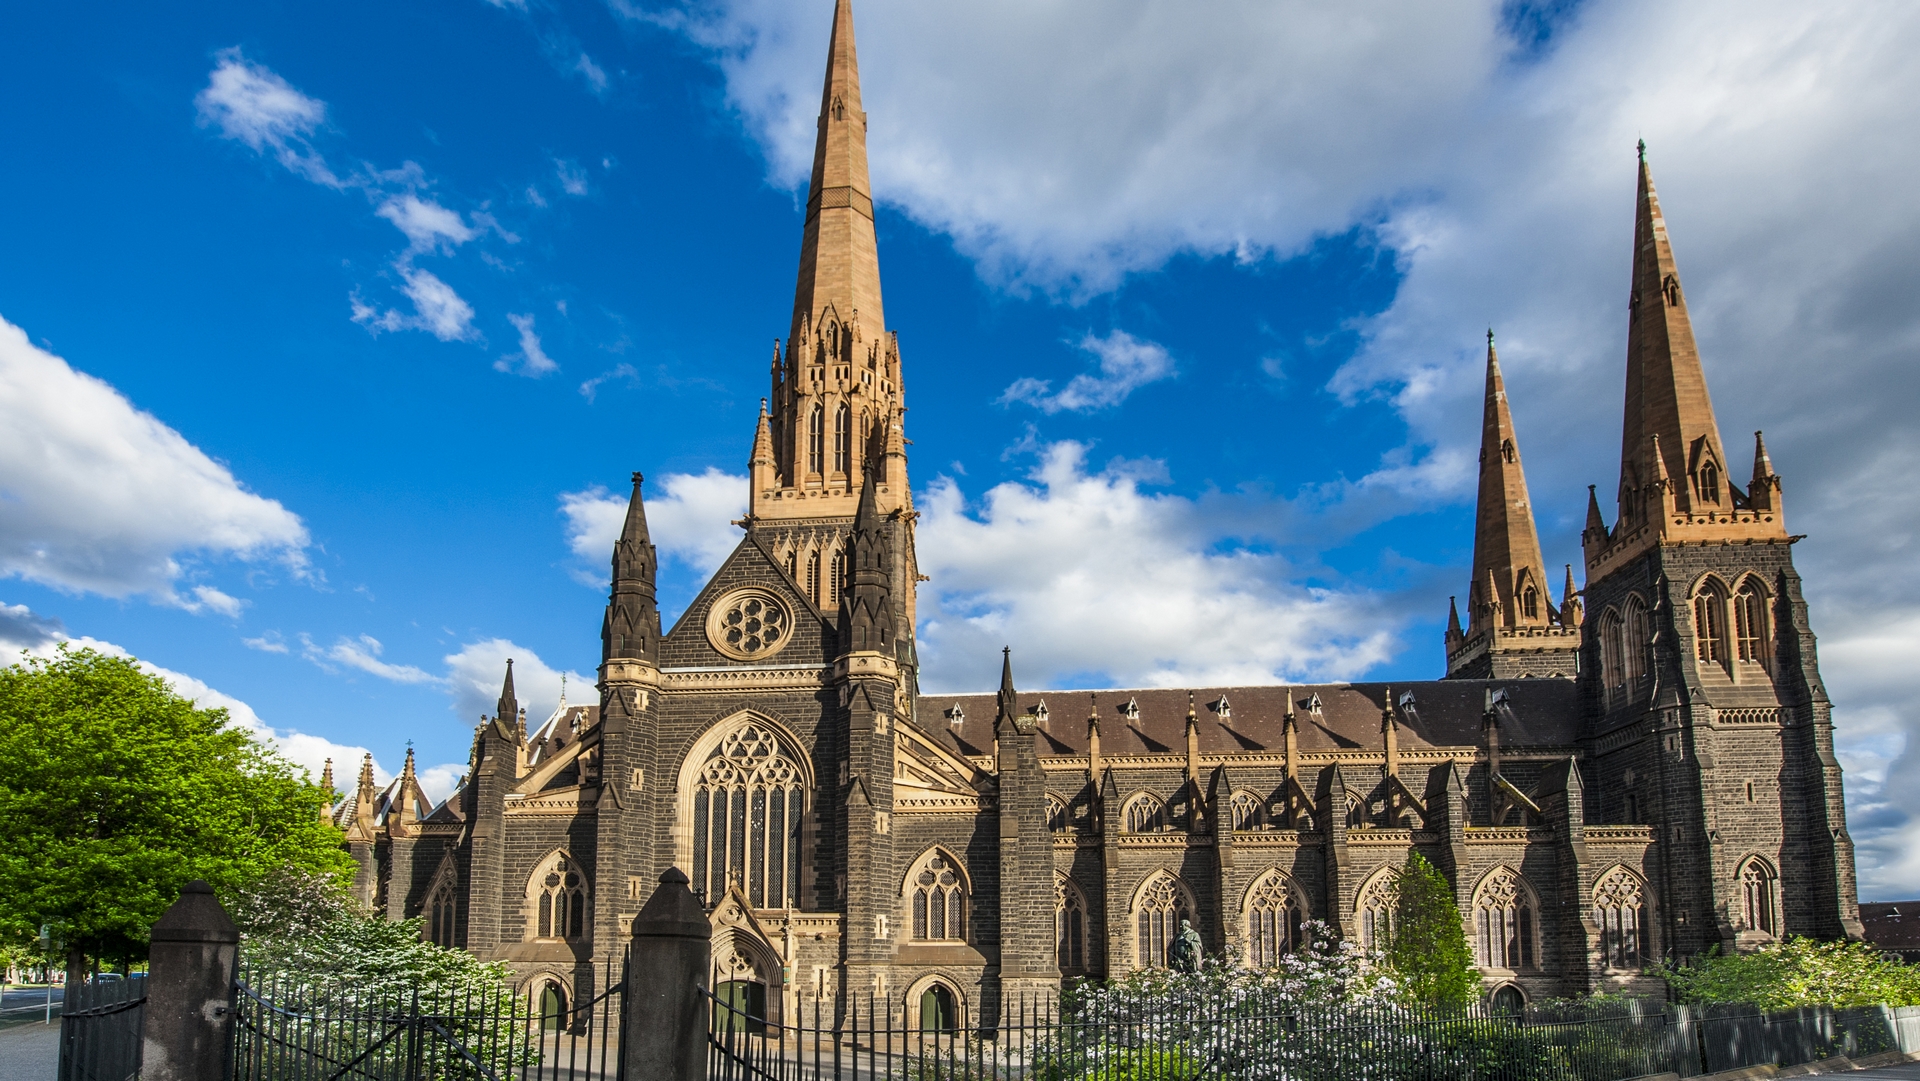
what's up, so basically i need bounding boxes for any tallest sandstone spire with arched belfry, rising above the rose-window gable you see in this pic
[749,0,912,520]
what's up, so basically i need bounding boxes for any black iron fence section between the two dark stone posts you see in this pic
[232,962,626,1081]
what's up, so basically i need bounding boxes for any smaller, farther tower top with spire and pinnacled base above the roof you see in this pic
[1446,330,1580,680]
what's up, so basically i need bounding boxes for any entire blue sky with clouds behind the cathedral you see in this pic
[0,0,1920,895]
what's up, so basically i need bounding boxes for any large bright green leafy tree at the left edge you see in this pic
[0,645,351,979]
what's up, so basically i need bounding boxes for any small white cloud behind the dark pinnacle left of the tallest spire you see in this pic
[561,467,747,588]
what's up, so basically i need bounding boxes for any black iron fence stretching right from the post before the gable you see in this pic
[707,991,1920,1081]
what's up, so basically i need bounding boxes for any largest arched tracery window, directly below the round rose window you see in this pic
[693,720,806,908]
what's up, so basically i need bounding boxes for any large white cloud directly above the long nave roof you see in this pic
[918,444,1396,689]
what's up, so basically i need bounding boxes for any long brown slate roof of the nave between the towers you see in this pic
[916,680,1580,757]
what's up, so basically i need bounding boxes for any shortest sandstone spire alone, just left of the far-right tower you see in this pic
[1467,330,1553,634]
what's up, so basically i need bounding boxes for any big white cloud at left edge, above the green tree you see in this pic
[0,319,309,616]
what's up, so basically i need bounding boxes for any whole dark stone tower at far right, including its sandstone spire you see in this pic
[1580,144,1860,954]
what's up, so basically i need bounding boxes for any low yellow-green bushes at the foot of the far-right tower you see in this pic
[1661,937,1920,1010]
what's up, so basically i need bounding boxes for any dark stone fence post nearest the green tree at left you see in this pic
[140,879,240,1081]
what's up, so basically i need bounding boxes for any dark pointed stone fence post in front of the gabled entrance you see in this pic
[620,868,712,1081]
